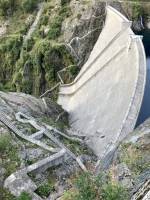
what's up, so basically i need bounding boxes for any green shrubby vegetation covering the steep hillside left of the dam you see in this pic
[0,0,75,95]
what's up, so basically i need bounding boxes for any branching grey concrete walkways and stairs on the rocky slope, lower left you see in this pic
[0,112,87,200]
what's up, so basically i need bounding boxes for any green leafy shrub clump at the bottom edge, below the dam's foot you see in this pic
[63,173,129,200]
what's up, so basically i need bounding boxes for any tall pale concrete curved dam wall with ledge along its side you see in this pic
[58,6,146,157]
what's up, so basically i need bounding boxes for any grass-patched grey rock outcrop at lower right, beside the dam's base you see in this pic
[110,119,150,199]
